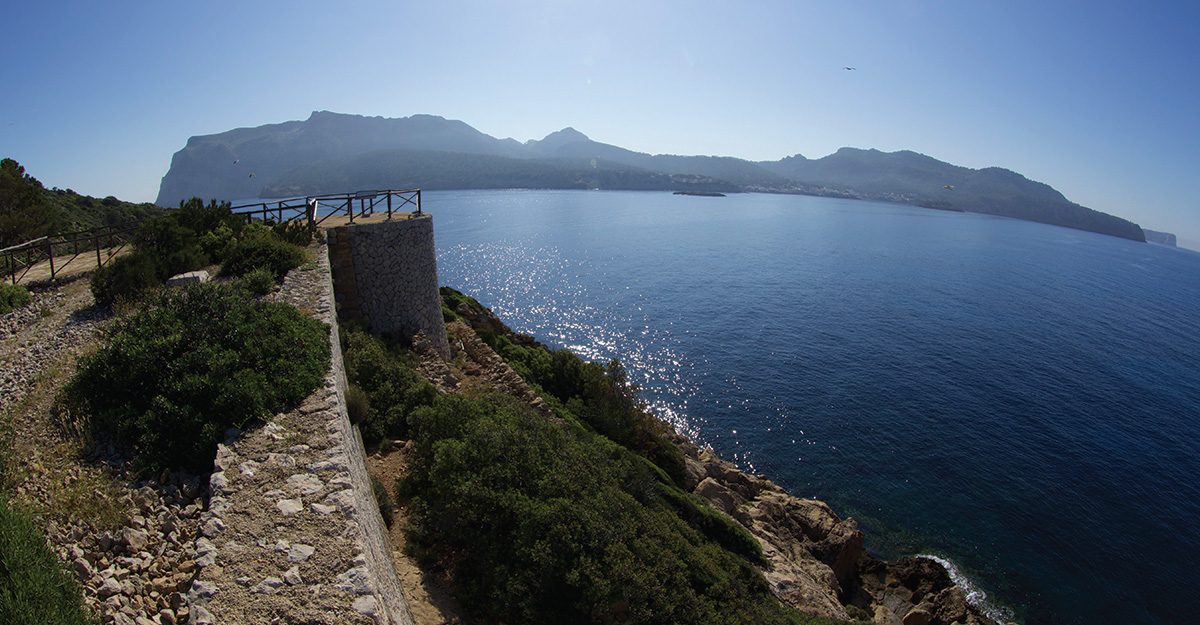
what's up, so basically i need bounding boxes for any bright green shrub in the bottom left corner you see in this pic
[0,498,100,625]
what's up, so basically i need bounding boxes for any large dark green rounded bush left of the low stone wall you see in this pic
[64,284,329,470]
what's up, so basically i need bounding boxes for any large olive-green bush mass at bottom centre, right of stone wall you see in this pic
[403,395,804,624]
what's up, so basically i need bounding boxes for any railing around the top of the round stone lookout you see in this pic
[232,188,421,226]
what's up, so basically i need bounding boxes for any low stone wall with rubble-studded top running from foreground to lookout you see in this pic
[187,239,412,624]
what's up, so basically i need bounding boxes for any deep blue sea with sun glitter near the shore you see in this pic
[422,191,1200,624]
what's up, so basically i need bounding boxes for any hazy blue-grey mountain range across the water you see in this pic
[156,112,1146,241]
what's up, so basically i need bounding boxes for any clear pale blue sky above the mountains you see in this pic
[0,0,1200,247]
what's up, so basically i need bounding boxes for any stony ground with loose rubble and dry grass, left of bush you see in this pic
[0,281,206,625]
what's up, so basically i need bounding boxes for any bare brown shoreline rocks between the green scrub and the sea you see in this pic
[454,295,1007,625]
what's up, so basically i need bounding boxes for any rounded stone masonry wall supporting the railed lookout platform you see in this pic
[334,214,450,360]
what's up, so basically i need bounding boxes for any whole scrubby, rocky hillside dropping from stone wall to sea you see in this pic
[343,288,992,625]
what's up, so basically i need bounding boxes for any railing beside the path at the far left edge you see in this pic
[0,221,142,284]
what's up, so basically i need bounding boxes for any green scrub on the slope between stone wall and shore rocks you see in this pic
[342,292,864,624]
